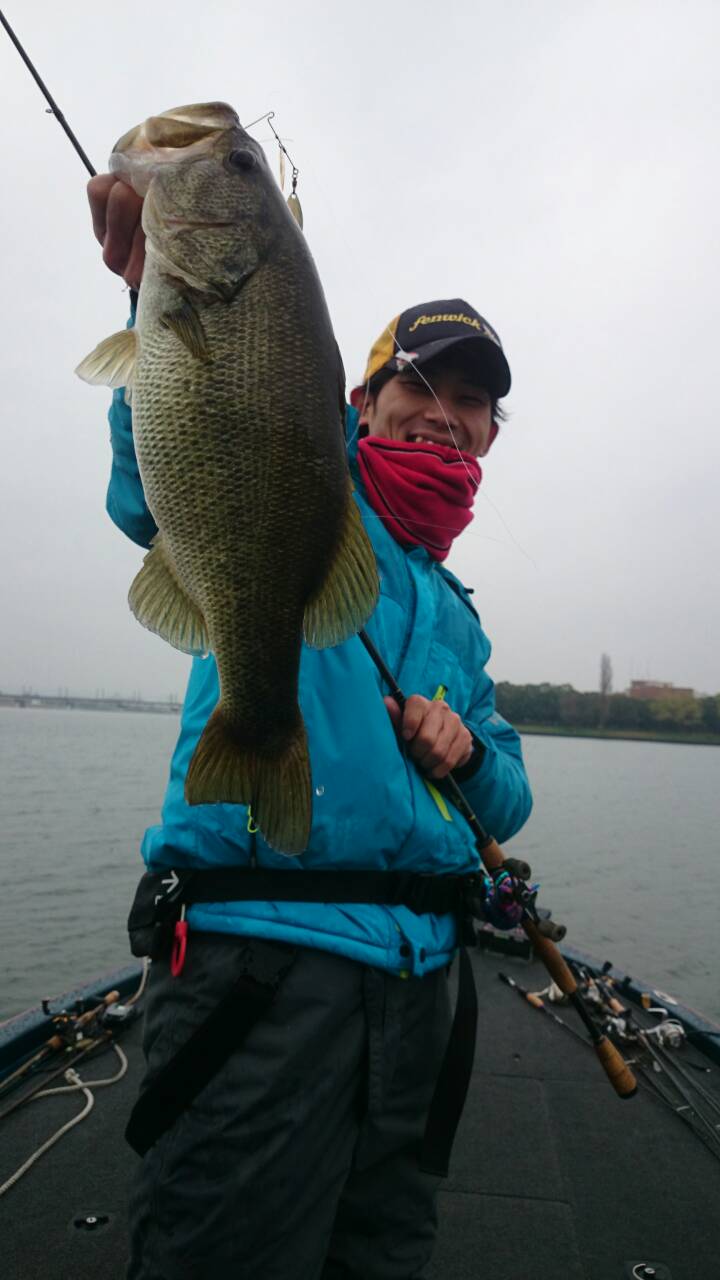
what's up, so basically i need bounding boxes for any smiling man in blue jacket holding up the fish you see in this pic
[88,175,530,1280]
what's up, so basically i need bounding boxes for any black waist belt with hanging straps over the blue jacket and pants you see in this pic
[126,867,480,1178]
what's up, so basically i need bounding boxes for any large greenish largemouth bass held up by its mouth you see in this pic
[76,102,379,855]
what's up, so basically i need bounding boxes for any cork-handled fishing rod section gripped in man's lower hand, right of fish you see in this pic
[359,631,638,1098]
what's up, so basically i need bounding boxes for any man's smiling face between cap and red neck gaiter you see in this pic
[360,353,497,458]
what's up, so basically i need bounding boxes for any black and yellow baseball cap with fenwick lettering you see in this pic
[353,298,511,399]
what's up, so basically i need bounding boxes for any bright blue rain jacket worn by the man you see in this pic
[108,366,532,974]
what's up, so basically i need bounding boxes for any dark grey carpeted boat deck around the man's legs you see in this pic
[0,952,720,1280]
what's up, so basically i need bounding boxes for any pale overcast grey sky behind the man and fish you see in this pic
[0,0,720,696]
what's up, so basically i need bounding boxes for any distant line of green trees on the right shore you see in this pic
[496,681,720,736]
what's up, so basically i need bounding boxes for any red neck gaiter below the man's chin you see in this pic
[357,435,483,561]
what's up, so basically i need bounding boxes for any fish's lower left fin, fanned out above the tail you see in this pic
[128,534,210,655]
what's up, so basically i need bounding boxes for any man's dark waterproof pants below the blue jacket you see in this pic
[122,934,451,1280]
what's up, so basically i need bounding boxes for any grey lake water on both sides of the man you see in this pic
[0,708,720,1021]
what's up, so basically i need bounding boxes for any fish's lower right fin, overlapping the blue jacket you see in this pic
[302,485,379,649]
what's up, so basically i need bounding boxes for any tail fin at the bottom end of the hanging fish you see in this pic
[184,707,313,854]
